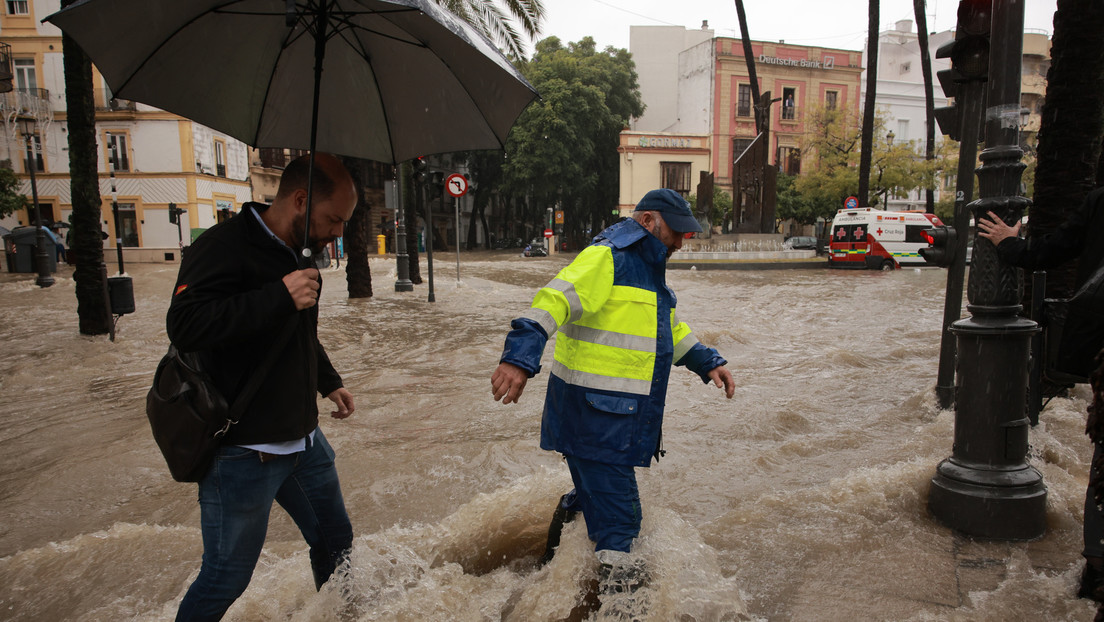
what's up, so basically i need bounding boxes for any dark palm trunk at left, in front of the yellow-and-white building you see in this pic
[62,0,112,335]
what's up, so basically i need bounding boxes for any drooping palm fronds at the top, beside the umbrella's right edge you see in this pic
[436,0,544,59]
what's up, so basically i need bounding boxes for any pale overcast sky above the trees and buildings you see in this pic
[539,0,1057,50]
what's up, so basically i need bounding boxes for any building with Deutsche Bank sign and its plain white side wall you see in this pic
[620,23,862,210]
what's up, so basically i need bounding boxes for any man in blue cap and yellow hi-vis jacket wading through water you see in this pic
[491,189,735,568]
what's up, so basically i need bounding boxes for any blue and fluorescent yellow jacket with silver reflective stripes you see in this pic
[501,219,725,466]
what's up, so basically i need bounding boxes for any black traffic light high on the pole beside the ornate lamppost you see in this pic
[935,0,992,140]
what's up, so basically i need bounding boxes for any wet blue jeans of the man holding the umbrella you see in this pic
[177,429,352,621]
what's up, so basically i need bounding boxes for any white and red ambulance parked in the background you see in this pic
[828,208,943,270]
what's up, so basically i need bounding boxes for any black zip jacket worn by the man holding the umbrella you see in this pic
[166,203,342,444]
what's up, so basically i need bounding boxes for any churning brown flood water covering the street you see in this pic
[0,252,1094,621]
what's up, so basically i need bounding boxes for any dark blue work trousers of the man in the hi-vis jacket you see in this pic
[563,455,640,552]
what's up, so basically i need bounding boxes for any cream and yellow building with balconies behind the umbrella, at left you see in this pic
[0,0,251,262]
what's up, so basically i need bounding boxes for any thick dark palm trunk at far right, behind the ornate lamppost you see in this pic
[1028,0,1104,297]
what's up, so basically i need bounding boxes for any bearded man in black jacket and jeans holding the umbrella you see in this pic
[167,154,357,621]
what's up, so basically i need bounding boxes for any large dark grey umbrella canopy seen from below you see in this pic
[44,0,537,164]
